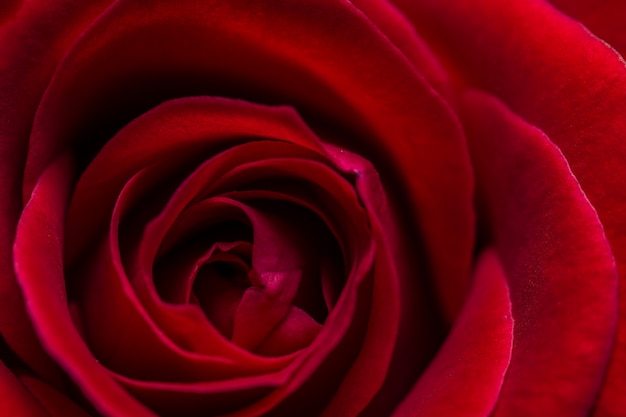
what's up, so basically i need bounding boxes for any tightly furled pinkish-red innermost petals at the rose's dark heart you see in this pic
[162,197,336,352]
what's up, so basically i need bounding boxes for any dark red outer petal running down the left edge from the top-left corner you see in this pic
[0,0,112,381]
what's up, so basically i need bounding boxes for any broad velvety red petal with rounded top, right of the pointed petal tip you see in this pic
[462,93,617,417]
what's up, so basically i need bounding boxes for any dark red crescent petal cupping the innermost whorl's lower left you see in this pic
[77,170,285,382]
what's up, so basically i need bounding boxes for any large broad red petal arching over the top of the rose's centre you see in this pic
[25,0,473,322]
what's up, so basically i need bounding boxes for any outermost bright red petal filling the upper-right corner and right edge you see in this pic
[396,0,626,415]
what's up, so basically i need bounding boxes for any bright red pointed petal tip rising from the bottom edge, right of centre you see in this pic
[393,250,513,417]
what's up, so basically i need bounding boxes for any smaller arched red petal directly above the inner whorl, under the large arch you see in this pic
[68,97,326,263]
